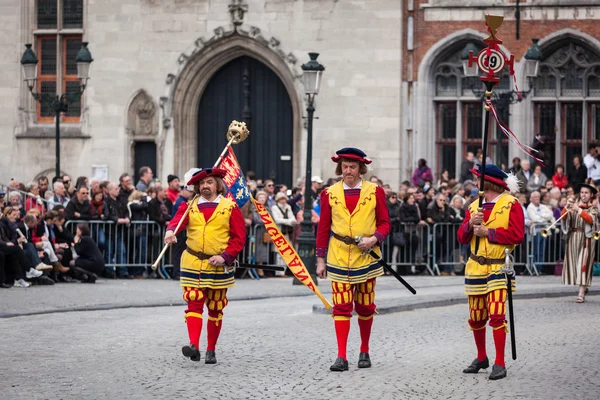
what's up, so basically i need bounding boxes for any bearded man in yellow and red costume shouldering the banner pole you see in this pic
[165,168,246,364]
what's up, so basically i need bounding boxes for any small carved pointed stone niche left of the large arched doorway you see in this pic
[125,89,164,180]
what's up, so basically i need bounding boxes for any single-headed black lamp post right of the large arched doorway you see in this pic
[294,53,325,285]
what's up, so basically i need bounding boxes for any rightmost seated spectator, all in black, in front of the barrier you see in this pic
[69,223,104,283]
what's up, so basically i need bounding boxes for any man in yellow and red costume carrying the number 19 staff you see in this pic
[457,164,525,380]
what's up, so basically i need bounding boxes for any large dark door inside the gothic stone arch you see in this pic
[197,56,294,186]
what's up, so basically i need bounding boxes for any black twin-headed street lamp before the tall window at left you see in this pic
[21,42,94,177]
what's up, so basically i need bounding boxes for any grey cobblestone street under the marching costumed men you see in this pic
[0,289,600,400]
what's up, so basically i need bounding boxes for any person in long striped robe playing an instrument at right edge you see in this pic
[561,183,598,303]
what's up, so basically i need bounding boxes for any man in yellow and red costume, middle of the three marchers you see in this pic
[316,147,390,371]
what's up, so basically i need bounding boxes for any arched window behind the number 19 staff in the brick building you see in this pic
[434,41,508,179]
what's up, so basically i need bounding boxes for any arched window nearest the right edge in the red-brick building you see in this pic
[533,38,600,175]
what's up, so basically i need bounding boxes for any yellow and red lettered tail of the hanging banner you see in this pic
[251,197,332,310]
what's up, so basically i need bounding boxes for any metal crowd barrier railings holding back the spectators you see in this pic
[59,220,600,278]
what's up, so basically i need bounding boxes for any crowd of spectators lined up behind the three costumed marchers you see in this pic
[0,145,600,287]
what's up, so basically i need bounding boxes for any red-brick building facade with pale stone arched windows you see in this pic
[401,0,600,181]
